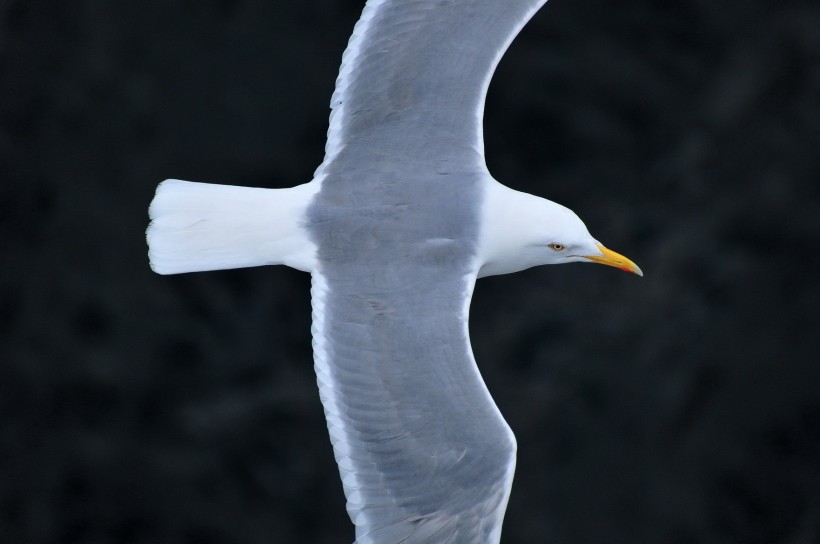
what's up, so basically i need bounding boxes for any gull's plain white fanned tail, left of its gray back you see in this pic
[146,179,319,274]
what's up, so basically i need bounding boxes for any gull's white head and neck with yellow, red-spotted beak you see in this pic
[479,184,643,276]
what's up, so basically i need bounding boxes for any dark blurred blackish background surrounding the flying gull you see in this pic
[0,0,820,544]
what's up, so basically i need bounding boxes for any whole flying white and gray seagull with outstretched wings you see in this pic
[147,0,643,544]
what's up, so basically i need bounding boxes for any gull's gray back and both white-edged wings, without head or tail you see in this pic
[309,0,543,544]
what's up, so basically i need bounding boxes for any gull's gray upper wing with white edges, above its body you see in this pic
[316,0,546,177]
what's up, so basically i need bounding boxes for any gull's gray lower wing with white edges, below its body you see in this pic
[311,266,515,544]
